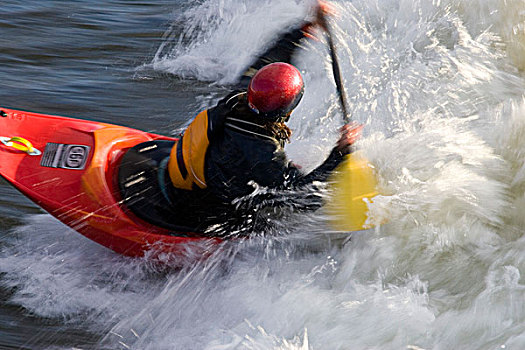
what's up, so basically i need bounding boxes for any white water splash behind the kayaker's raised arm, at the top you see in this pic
[152,0,305,84]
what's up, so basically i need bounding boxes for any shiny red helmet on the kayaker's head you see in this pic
[248,62,304,121]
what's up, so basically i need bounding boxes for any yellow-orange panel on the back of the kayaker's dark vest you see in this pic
[168,111,210,190]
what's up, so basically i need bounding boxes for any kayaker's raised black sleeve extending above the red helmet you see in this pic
[237,22,311,88]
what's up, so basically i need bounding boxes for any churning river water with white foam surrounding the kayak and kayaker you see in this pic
[0,0,525,350]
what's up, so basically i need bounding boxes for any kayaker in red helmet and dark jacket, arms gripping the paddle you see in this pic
[119,1,362,234]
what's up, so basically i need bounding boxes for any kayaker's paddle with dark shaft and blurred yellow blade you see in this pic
[323,18,378,231]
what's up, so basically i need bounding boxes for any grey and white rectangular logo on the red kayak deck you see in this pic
[40,142,90,170]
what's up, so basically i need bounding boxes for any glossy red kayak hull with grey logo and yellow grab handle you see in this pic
[0,107,218,259]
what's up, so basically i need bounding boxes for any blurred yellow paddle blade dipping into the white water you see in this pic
[326,152,378,231]
